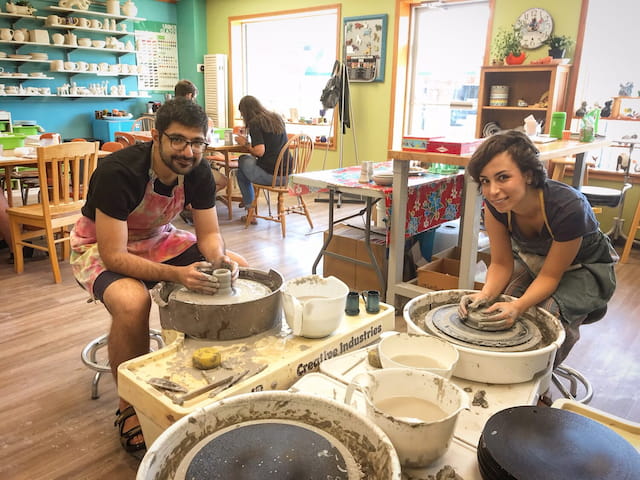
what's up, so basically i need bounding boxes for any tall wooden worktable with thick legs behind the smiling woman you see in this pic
[386,138,611,305]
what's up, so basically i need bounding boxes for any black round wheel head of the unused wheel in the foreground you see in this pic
[175,420,361,480]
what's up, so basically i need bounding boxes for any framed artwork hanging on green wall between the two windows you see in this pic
[343,13,387,82]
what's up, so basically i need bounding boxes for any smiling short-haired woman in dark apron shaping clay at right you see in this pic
[459,131,617,365]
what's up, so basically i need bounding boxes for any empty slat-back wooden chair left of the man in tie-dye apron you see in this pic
[7,142,99,283]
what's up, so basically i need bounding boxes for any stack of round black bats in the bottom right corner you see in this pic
[477,406,640,480]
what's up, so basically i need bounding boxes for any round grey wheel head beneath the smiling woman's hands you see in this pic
[425,304,542,351]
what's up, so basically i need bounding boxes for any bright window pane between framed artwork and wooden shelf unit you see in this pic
[404,1,490,138]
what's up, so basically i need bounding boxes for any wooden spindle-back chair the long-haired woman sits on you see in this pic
[245,133,313,237]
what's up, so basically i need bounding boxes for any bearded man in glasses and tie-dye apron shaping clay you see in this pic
[71,99,247,455]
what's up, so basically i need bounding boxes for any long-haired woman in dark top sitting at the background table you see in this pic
[236,95,288,224]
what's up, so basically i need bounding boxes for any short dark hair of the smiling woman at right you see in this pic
[467,130,547,188]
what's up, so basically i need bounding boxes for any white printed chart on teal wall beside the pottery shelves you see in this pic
[135,21,179,92]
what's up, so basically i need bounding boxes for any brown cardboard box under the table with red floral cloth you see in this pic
[322,225,387,291]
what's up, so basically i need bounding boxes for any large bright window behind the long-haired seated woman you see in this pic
[230,8,340,141]
